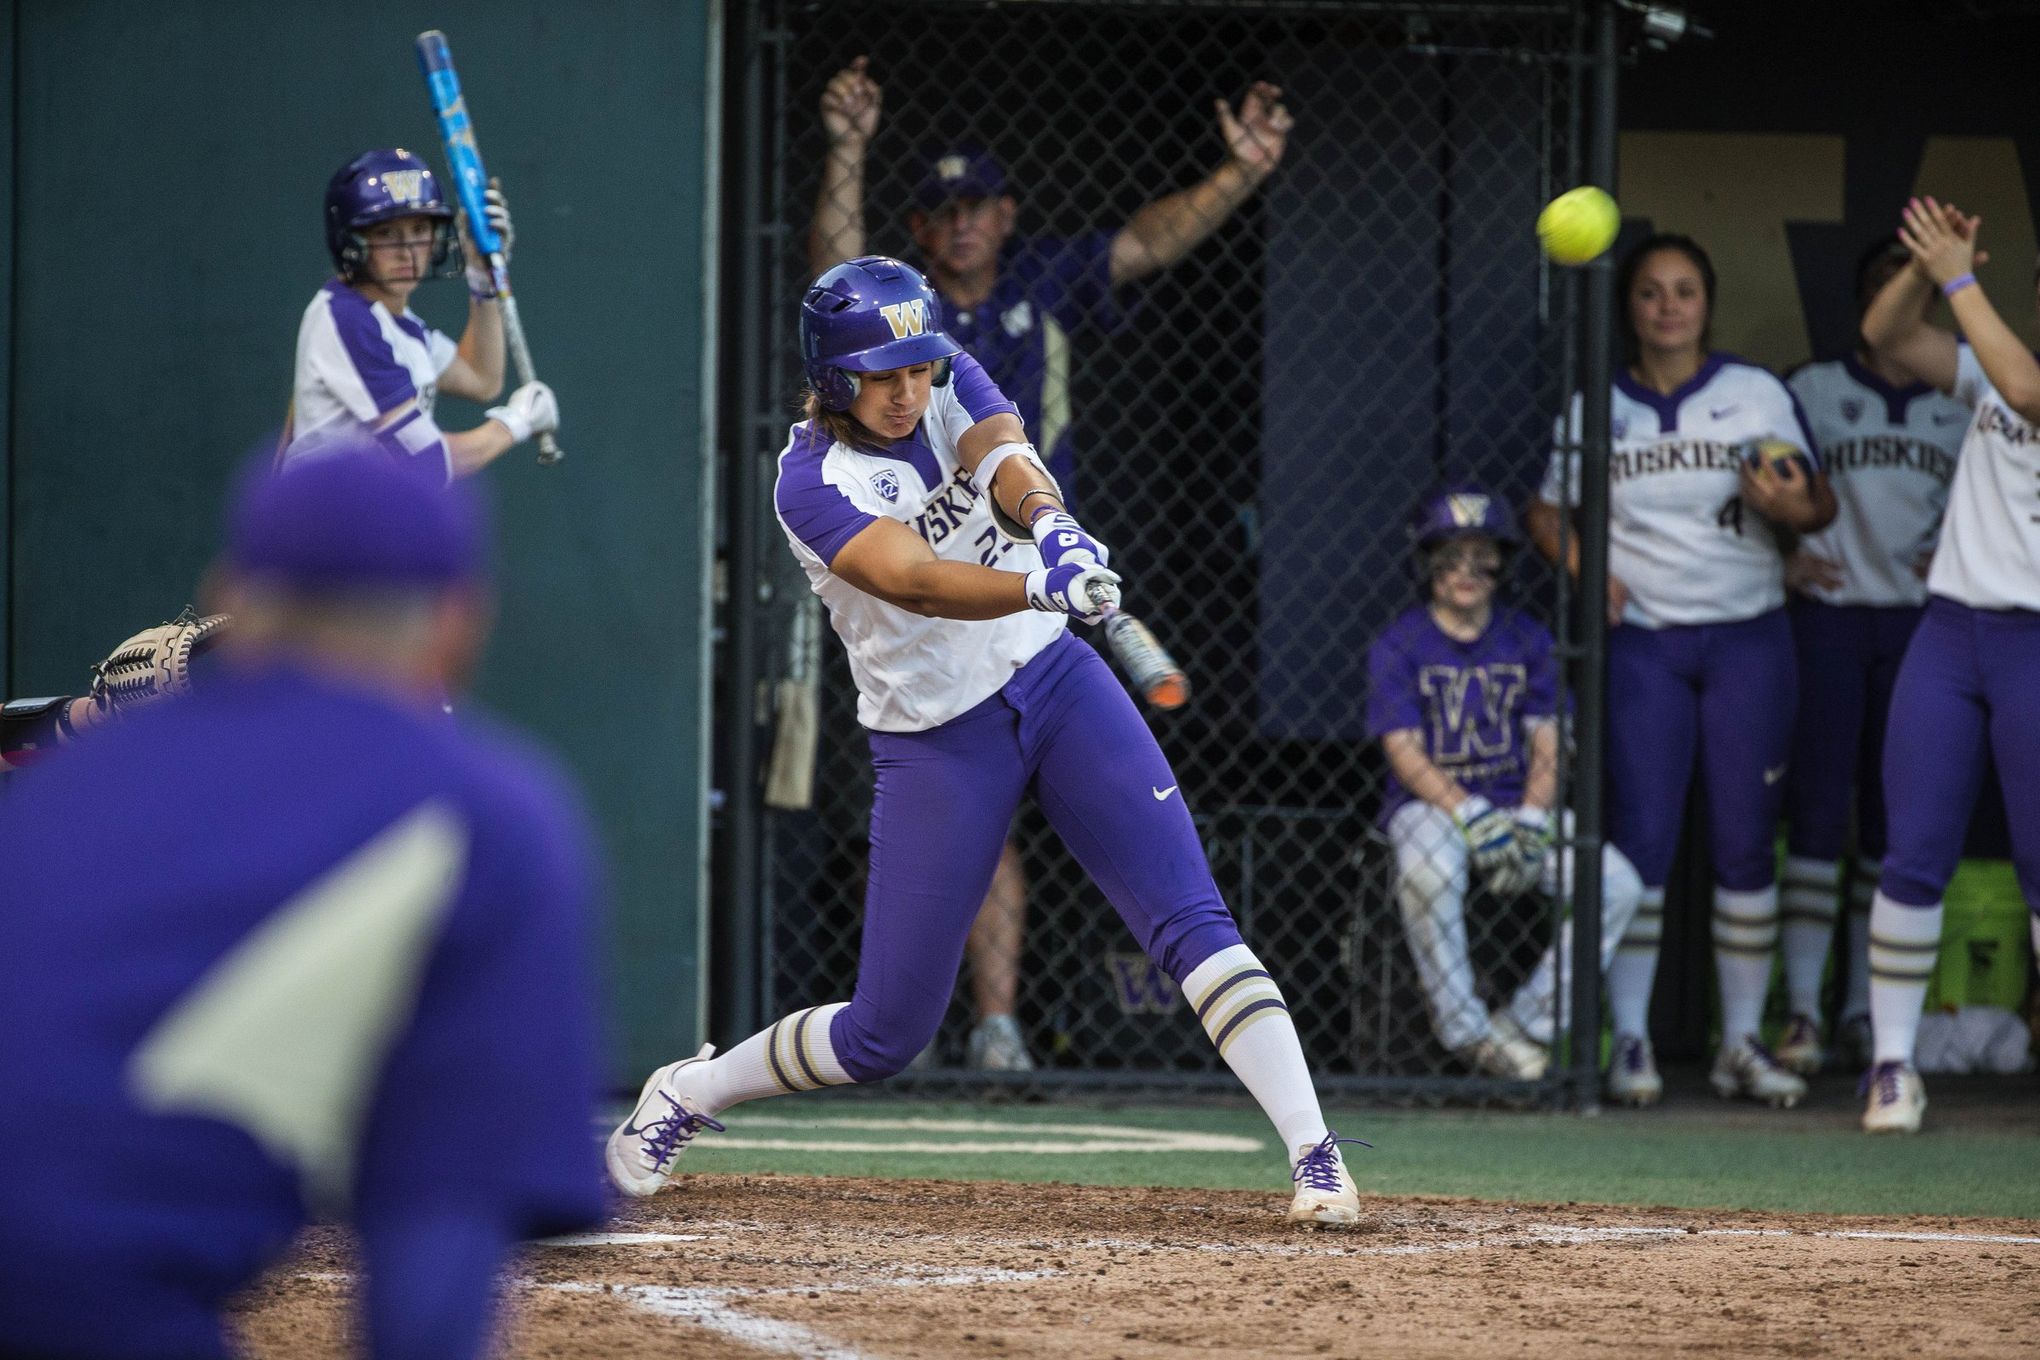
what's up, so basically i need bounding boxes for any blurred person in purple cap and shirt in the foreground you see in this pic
[0,455,602,1358]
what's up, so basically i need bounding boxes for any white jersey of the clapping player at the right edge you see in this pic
[1926,345,2040,610]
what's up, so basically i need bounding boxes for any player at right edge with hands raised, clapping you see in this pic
[1863,198,2040,1134]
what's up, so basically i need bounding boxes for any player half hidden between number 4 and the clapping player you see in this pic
[1777,237,1969,1077]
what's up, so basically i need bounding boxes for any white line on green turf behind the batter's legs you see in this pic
[700,1115,1267,1156]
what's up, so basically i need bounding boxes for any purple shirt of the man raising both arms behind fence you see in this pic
[942,232,1124,495]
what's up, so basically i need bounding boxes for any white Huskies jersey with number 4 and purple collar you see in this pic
[1538,355,1820,628]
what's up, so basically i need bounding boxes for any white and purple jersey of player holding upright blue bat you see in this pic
[284,279,459,479]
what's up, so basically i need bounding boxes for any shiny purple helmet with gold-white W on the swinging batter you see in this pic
[800,255,963,410]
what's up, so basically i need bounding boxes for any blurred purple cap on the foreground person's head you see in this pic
[226,447,490,589]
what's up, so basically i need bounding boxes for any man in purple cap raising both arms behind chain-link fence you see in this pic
[808,57,1293,1070]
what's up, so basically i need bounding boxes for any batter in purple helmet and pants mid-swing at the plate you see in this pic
[608,255,1359,1223]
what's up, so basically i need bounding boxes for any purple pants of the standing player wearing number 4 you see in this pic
[1608,610,1799,893]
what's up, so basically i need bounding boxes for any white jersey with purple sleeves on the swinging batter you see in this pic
[773,355,1069,732]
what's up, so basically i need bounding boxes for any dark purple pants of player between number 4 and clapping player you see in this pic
[1785,599,1920,860]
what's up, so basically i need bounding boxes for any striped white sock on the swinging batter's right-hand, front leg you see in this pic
[1183,944,1326,1162]
